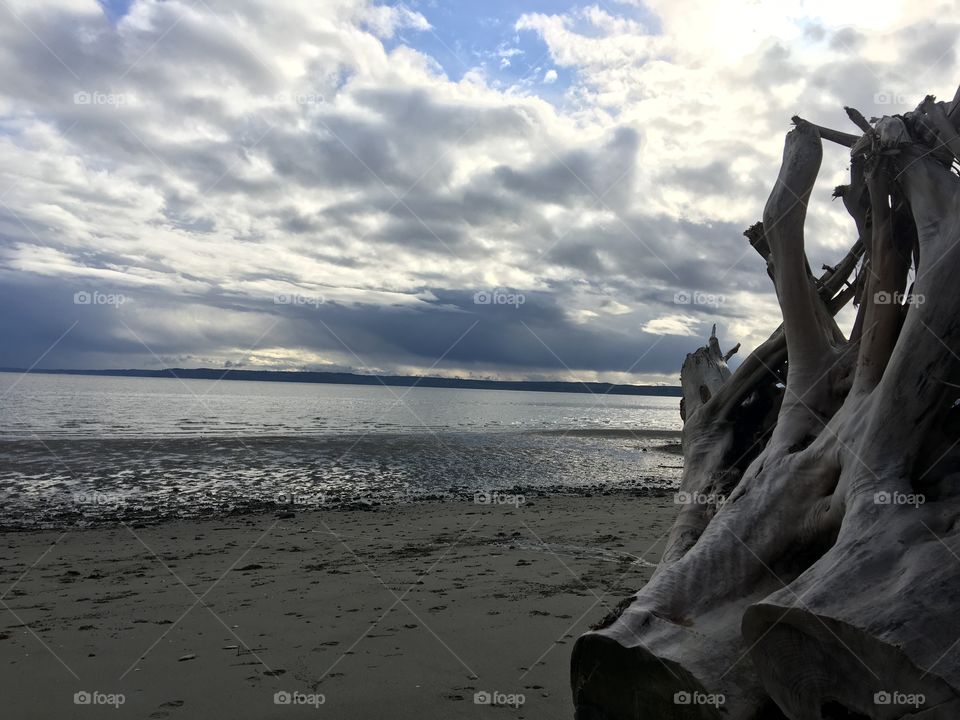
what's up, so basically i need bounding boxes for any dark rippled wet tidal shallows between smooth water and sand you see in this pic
[0,431,682,530]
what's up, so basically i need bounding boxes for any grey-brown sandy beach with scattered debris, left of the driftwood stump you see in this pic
[0,492,675,720]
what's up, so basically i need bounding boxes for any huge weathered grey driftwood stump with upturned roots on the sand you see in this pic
[571,90,960,720]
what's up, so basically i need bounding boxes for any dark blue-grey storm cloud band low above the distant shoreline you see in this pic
[0,275,699,375]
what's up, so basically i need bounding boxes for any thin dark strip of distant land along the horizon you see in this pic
[0,368,683,397]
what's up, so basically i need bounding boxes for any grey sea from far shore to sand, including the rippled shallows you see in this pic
[0,373,681,528]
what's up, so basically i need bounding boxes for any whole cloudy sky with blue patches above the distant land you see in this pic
[0,0,960,384]
